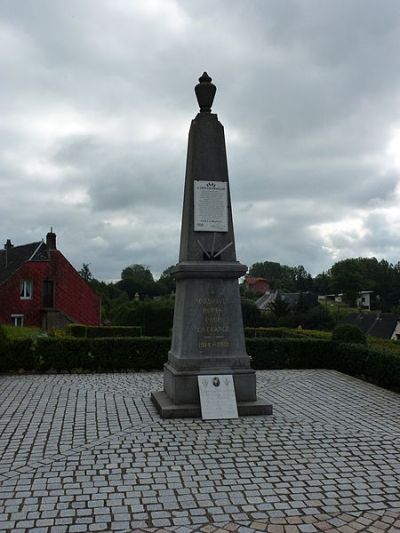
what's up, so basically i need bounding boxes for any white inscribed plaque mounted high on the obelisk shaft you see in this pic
[194,180,228,232]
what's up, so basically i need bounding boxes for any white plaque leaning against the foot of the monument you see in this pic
[197,374,238,420]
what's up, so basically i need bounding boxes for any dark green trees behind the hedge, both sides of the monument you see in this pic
[80,257,400,335]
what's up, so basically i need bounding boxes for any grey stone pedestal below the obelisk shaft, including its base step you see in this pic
[151,261,272,418]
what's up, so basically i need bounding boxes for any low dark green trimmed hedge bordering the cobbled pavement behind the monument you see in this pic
[0,337,400,390]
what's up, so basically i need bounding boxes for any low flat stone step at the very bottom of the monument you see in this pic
[151,391,272,418]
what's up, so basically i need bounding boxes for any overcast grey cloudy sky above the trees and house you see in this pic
[0,0,400,280]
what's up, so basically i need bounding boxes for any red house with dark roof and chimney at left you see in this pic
[0,231,100,329]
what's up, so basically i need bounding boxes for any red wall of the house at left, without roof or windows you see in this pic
[0,250,100,327]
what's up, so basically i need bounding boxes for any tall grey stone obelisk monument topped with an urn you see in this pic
[152,73,272,418]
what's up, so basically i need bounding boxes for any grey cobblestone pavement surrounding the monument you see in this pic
[0,370,400,533]
